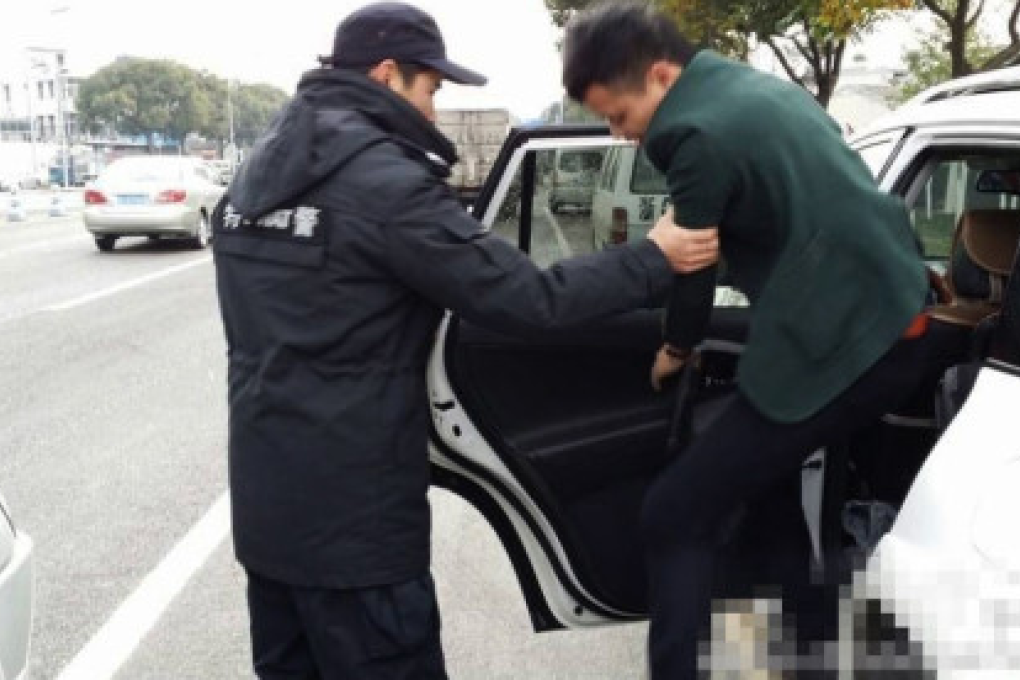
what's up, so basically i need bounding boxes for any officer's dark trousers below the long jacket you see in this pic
[248,570,447,680]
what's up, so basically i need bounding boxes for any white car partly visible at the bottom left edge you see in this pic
[0,496,34,680]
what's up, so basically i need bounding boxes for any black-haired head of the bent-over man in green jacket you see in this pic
[563,2,697,142]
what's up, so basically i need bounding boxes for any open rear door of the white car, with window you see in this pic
[428,126,748,630]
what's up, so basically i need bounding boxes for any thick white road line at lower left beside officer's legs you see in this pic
[57,491,231,680]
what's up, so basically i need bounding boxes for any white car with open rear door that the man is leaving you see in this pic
[428,70,1020,680]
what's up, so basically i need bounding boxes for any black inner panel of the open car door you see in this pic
[447,309,747,613]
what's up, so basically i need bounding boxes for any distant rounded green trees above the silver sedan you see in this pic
[77,57,287,145]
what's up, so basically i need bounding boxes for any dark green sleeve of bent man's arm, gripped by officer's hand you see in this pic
[655,129,735,348]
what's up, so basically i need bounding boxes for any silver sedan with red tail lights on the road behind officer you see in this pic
[83,156,224,252]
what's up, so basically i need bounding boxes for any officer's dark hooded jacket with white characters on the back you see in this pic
[213,69,671,588]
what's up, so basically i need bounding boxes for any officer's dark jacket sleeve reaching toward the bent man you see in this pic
[385,175,672,333]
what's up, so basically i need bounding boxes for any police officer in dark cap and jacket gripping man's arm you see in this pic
[213,3,712,680]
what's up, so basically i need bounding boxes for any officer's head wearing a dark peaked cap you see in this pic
[319,2,486,120]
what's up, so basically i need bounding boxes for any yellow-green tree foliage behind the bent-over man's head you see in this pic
[546,0,909,106]
